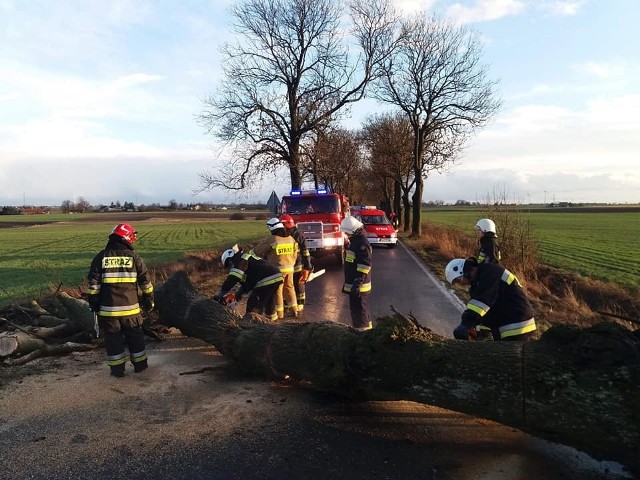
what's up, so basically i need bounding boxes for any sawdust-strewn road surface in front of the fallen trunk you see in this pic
[0,332,632,480]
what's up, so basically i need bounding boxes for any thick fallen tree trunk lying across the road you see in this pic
[156,272,640,473]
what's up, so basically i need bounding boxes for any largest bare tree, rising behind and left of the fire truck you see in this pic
[198,0,397,191]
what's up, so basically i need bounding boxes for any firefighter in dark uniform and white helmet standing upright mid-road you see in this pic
[340,216,373,331]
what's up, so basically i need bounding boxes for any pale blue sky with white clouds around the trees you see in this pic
[0,0,640,206]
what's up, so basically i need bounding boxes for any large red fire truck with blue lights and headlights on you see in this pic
[280,189,349,265]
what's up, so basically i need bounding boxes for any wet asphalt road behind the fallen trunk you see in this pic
[305,243,463,338]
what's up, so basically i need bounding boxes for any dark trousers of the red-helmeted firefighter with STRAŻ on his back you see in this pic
[100,319,148,377]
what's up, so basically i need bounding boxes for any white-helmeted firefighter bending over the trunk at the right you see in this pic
[445,257,536,341]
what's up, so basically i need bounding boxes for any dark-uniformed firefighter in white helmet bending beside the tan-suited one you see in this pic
[213,245,282,322]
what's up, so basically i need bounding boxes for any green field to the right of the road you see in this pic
[423,208,640,288]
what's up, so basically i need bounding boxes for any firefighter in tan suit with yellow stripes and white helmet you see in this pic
[253,217,298,319]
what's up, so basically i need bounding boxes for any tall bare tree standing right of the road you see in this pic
[375,15,500,237]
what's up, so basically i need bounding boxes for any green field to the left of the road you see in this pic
[0,213,268,305]
